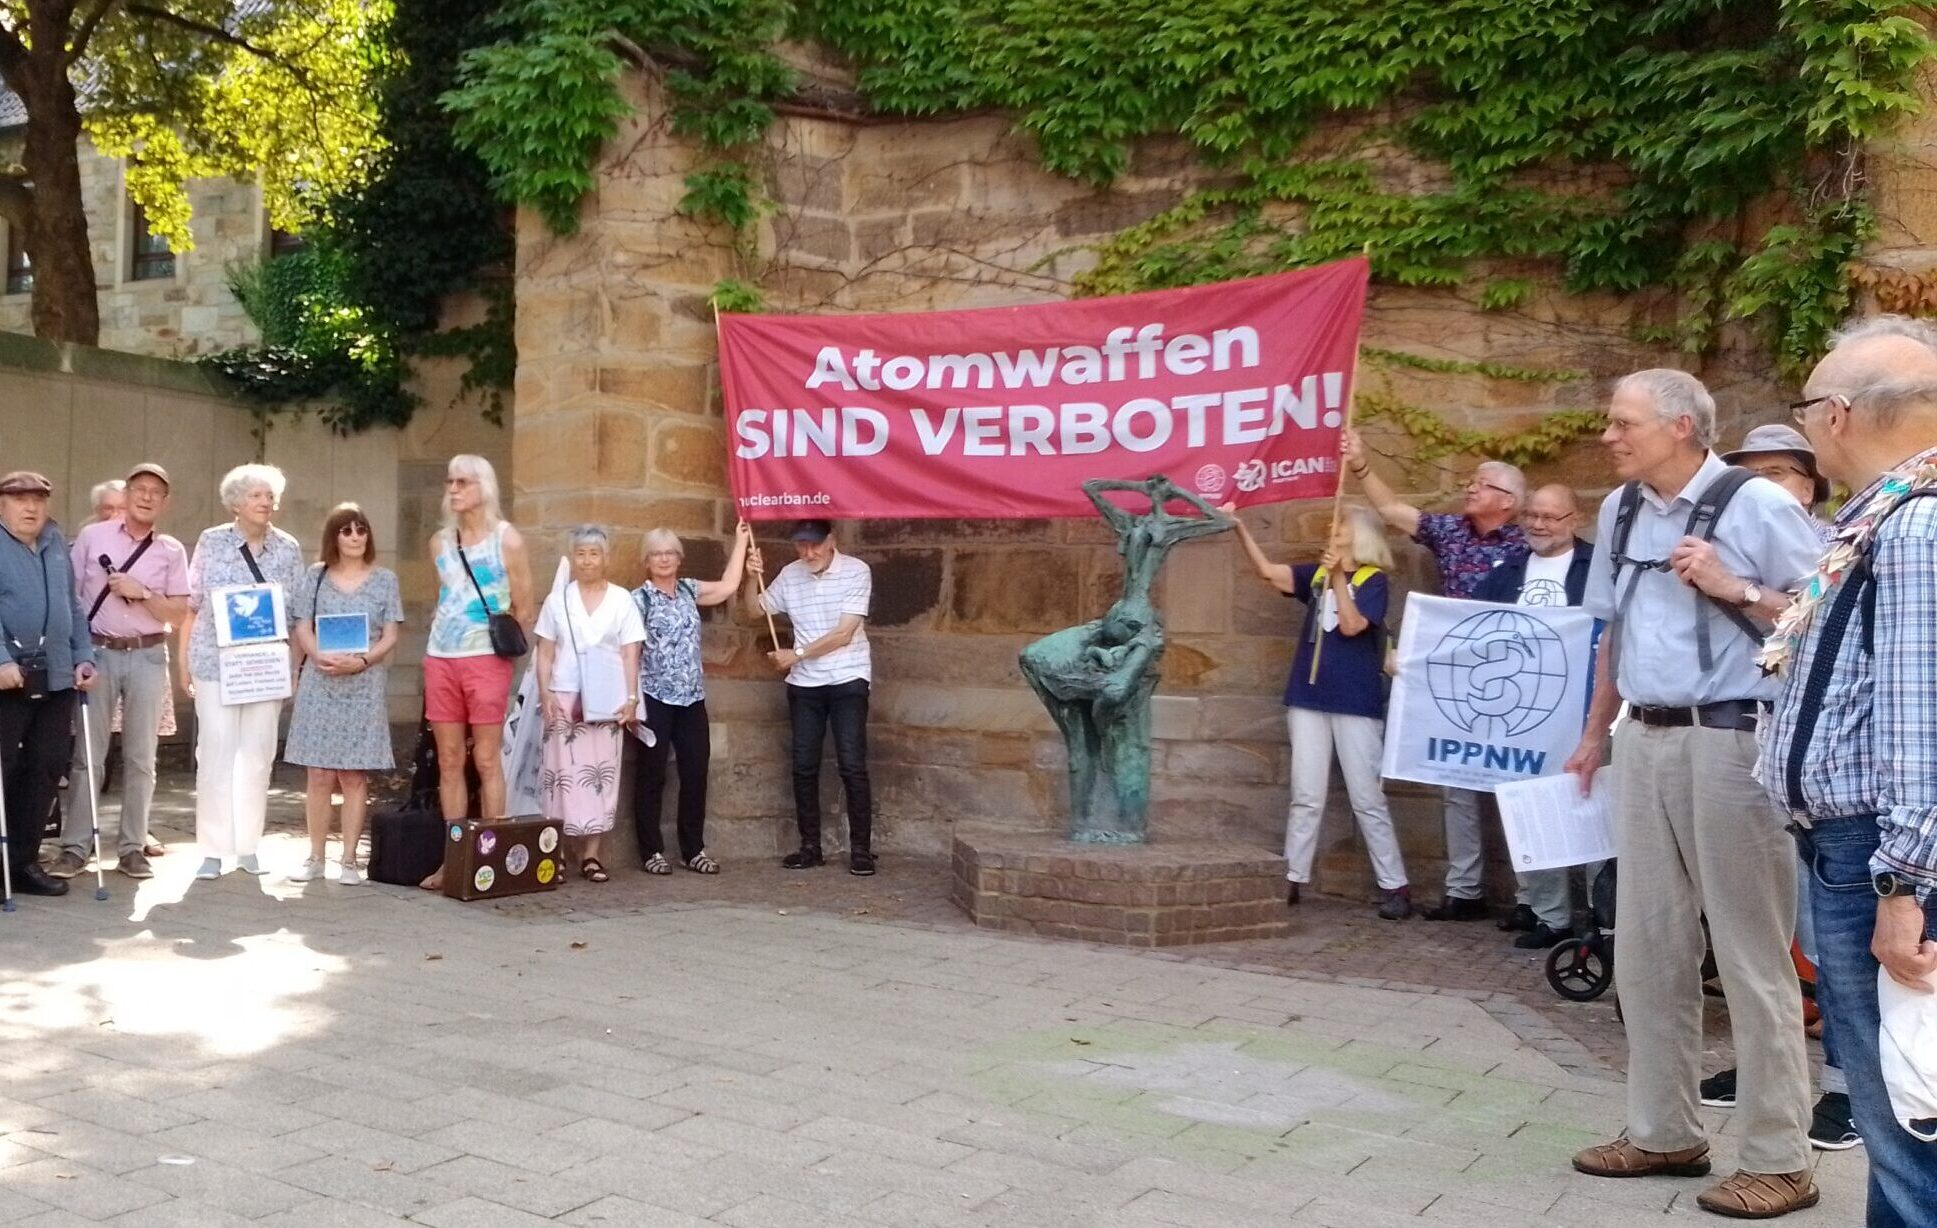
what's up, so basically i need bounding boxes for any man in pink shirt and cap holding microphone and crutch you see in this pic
[46,463,188,877]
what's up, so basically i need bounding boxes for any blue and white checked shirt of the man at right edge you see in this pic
[1763,455,1937,897]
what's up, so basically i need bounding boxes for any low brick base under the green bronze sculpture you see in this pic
[949,829,1292,947]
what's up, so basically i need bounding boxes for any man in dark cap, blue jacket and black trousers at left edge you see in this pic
[0,471,95,895]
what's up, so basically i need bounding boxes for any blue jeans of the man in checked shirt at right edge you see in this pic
[1796,815,1937,1228]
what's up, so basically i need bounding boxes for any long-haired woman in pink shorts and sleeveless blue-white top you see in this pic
[422,455,535,891]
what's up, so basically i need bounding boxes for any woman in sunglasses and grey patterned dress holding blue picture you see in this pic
[283,504,403,885]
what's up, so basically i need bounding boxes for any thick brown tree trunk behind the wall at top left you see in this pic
[21,54,99,345]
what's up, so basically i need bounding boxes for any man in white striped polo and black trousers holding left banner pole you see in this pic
[746,521,874,875]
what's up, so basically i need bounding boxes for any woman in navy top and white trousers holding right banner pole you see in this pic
[1222,504,1412,920]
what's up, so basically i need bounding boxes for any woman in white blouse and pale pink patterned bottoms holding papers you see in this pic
[535,525,645,883]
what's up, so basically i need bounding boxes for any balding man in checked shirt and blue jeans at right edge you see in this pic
[1766,316,1937,1228]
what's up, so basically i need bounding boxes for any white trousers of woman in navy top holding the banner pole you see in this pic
[1284,707,1406,891]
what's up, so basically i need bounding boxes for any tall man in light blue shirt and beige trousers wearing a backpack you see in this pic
[1567,370,1821,1218]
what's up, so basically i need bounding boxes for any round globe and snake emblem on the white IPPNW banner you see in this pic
[1426,610,1567,738]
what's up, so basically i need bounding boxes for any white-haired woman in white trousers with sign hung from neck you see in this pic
[186,465,302,879]
